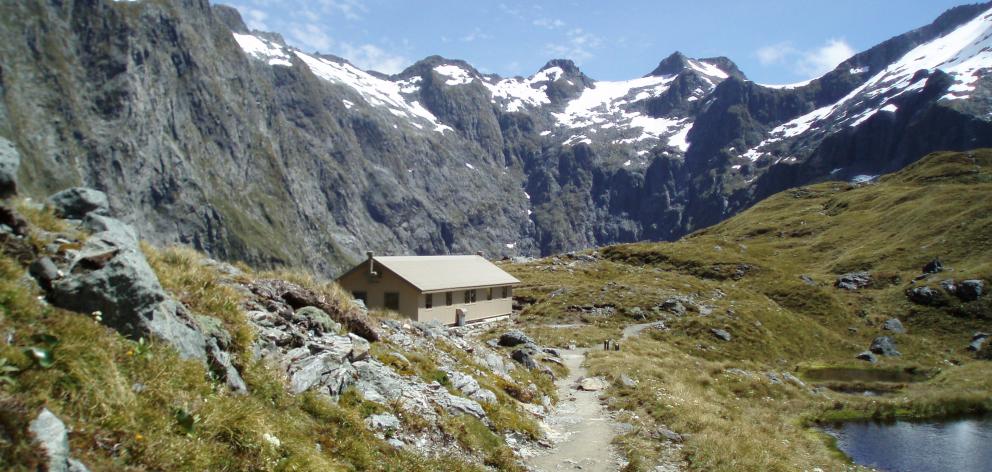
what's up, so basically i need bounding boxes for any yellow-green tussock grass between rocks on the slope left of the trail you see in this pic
[0,211,553,471]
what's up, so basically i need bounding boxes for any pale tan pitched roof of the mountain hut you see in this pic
[362,256,520,292]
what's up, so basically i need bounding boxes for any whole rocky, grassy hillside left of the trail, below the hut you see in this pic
[0,183,564,472]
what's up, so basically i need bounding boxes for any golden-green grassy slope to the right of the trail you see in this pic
[509,150,992,470]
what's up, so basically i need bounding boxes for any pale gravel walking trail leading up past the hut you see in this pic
[526,322,672,472]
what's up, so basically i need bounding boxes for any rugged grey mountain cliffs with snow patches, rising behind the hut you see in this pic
[0,0,992,274]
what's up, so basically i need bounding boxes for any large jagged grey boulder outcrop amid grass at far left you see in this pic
[36,189,247,393]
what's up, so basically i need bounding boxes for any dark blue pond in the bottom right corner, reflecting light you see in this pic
[826,416,992,472]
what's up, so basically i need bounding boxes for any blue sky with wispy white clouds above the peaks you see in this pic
[227,0,976,83]
